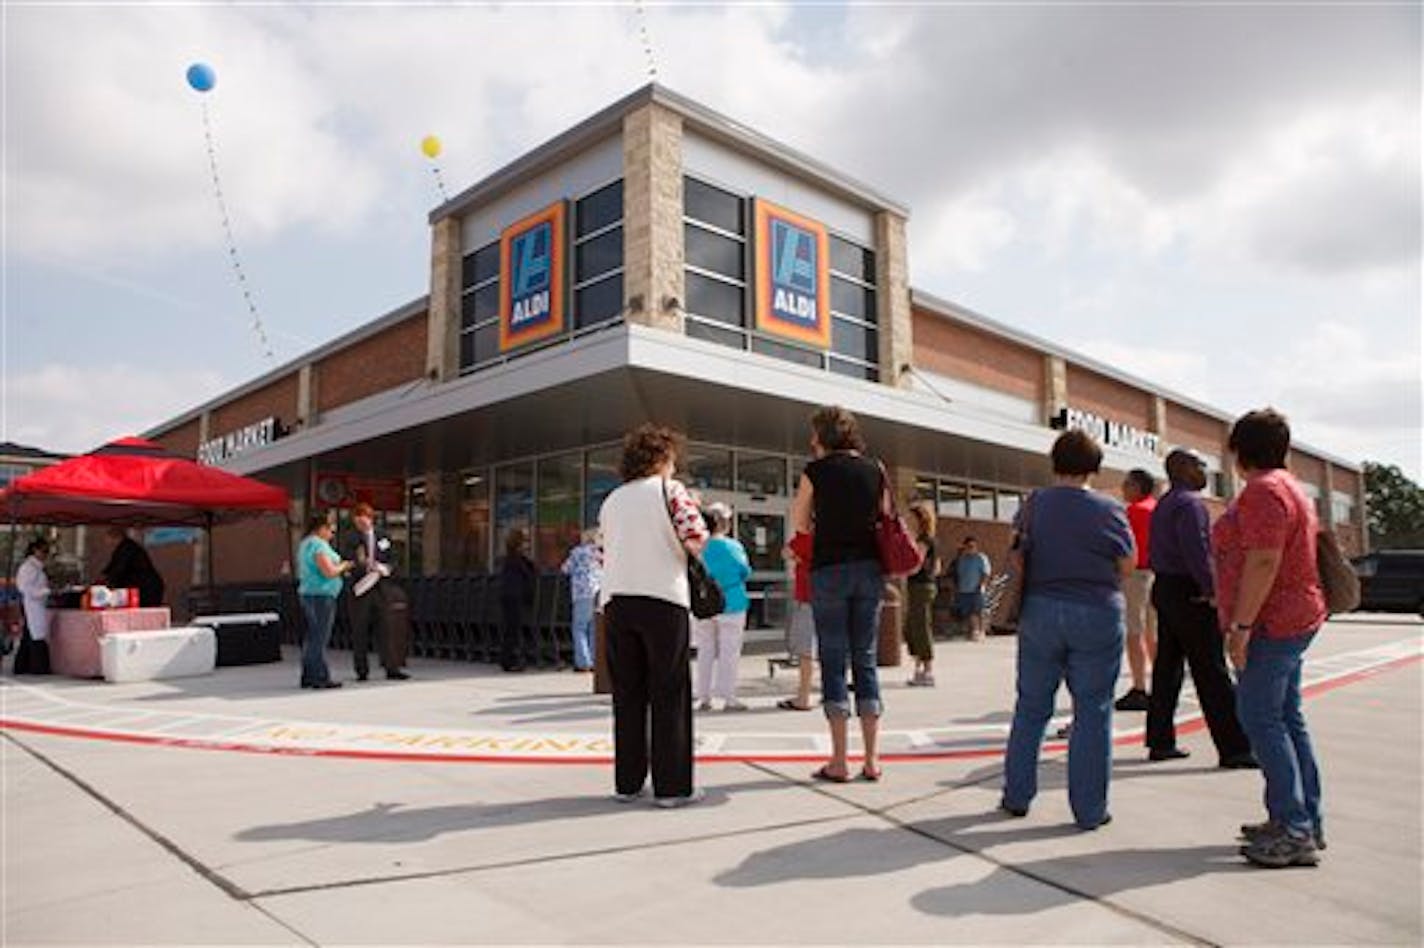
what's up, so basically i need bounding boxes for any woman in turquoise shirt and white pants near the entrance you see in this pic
[693,504,752,710]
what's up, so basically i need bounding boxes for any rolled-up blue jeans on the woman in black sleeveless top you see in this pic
[810,559,884,717]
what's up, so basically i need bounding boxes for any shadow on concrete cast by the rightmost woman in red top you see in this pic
[910,836,1249,917]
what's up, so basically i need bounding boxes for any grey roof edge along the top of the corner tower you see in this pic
[429,83,910,223]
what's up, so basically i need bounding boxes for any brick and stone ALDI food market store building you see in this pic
[148,85,1364,623]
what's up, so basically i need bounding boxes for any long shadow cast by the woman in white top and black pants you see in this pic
[234,780,786,843]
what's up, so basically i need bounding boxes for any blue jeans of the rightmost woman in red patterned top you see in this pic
[1236,631,1321,836]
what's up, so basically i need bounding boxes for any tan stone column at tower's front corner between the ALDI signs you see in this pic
[624,104,686,333]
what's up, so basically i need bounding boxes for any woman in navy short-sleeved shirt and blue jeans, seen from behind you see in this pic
[1000,431,1136,830]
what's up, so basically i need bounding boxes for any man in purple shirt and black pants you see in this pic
[1146,448,1256,769]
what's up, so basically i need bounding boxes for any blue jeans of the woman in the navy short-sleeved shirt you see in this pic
[1004,595,1124,830]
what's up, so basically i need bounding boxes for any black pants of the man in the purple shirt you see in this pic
[1146,572,1250,760]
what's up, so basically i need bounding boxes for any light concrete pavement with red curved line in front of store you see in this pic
[0,619,1424,945]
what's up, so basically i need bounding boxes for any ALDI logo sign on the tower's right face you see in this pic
[753,199,830,349]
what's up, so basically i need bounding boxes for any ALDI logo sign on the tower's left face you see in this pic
[500,201,564,352]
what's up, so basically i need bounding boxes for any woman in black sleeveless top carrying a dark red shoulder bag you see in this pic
[792,407,884,783]
